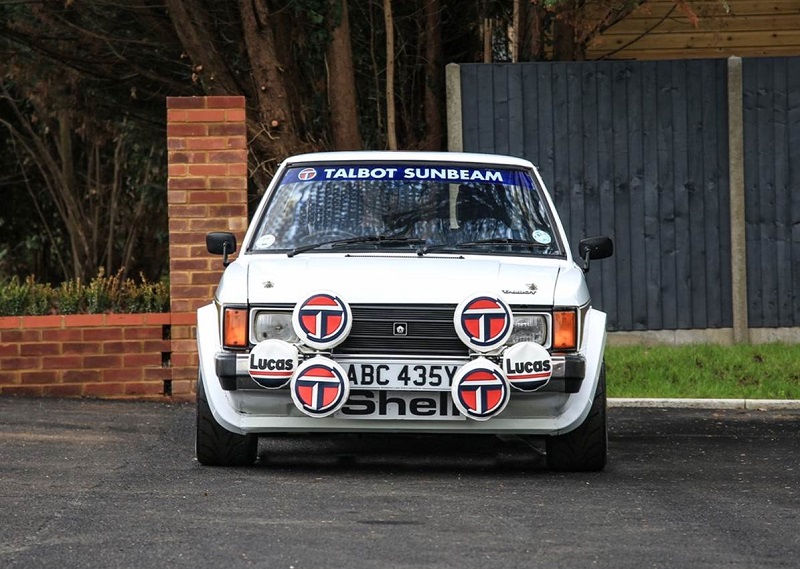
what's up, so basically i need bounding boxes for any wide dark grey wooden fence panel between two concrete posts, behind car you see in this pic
[461,60,732,330]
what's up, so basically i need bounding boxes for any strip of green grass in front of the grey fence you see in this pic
[605,344,800,399]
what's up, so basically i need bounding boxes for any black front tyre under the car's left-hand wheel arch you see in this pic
[195,372,258,466]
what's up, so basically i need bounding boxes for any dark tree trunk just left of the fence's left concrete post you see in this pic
[422,0,444,151]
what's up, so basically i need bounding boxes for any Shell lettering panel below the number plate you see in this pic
[335,389,466,421]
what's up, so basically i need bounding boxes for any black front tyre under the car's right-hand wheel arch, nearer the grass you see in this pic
[547,364,608,472]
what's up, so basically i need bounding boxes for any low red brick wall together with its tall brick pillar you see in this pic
[0,97,247,400]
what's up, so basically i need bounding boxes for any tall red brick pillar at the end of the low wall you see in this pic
[167,97,247,398]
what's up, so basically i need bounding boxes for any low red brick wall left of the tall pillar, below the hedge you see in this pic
[0,314,172,399]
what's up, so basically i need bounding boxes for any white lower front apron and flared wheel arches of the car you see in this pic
[197,305,606,435]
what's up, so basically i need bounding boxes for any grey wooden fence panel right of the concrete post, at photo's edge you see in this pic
[742,58,800,328]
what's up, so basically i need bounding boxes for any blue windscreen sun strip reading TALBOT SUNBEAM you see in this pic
[282,165,527,184]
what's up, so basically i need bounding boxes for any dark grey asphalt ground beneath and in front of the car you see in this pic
[0,398,800,569]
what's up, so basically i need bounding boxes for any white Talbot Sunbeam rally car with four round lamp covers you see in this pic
[196,152,613,470]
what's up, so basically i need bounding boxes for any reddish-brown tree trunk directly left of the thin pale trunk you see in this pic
[328,0,362,150]
